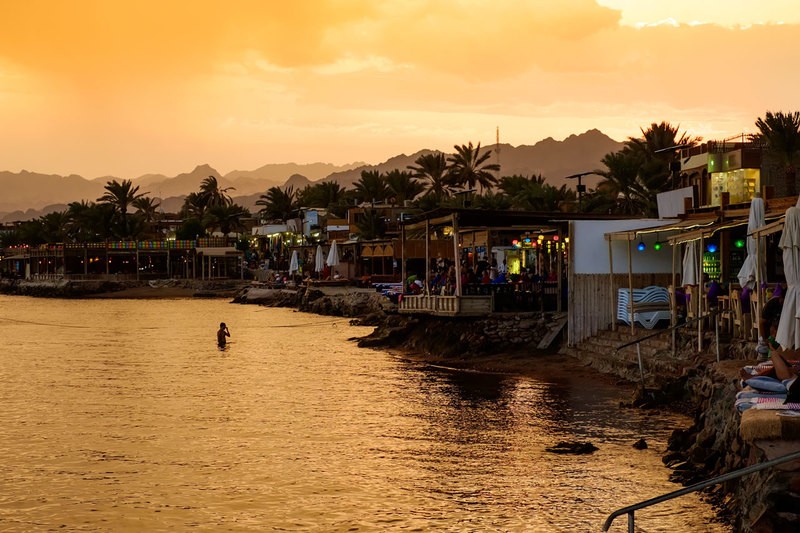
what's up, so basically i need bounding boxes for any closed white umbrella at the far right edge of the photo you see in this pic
[775,206,800,349]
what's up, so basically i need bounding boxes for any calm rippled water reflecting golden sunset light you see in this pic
[0,296,727,532]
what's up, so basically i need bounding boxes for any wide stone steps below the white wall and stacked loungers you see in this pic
[559,328,696,386]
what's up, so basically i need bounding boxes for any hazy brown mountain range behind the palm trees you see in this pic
[0,129,623,222]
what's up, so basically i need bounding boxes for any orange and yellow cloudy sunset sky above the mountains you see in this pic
[0,0,800,178]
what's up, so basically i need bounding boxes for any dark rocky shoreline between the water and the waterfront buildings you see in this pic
[0,282,785,530]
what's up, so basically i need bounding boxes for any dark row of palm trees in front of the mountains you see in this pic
[1,111,800,246]
